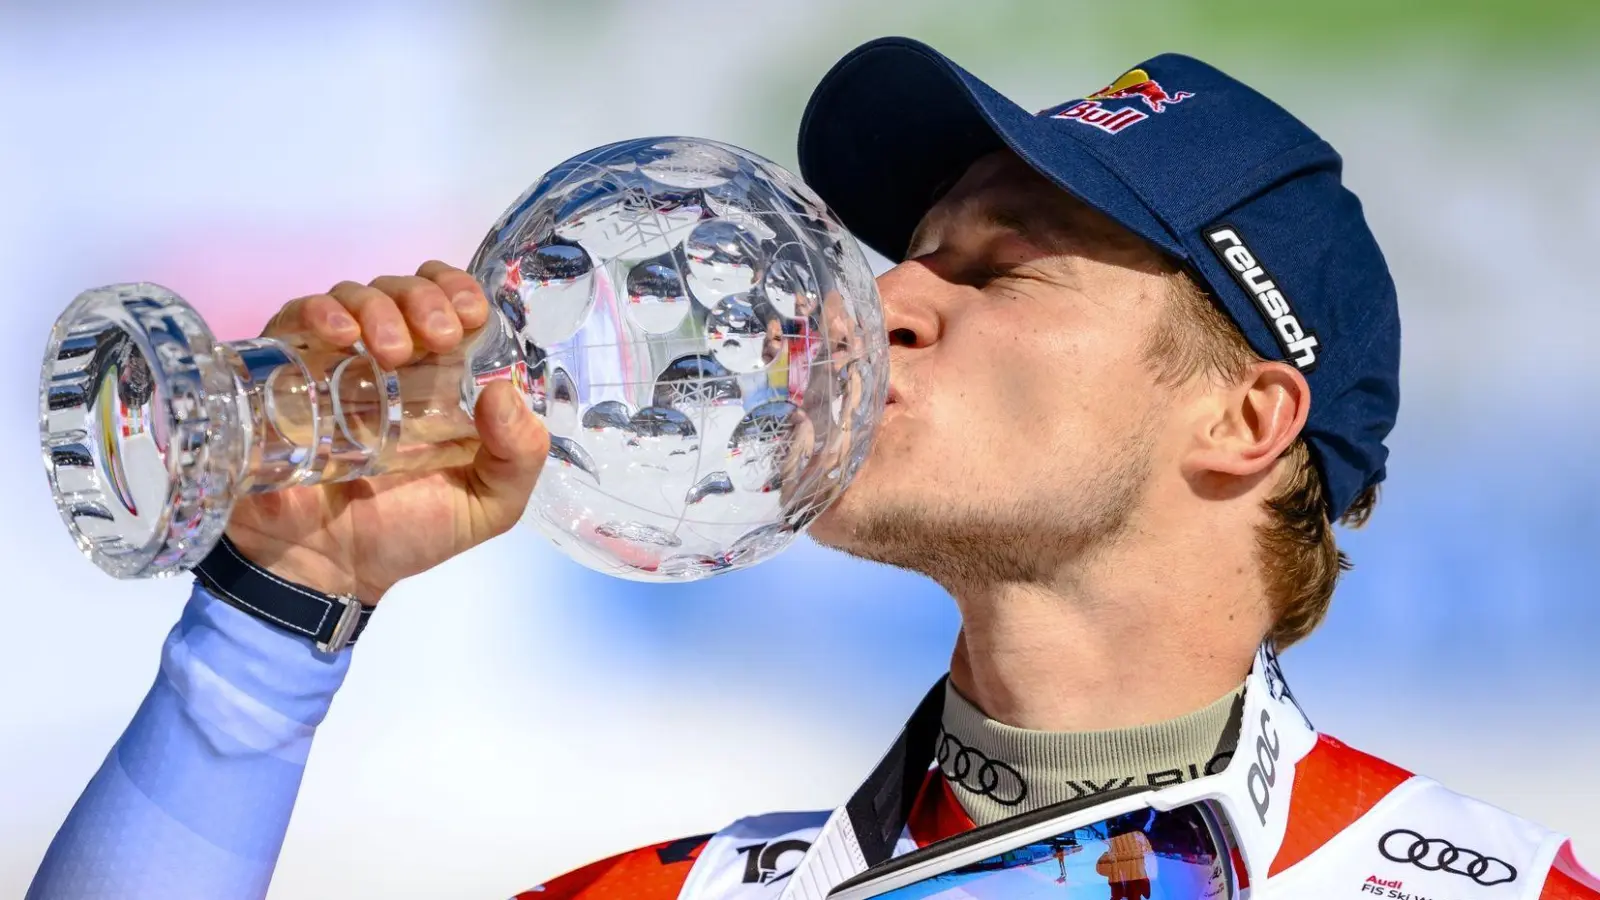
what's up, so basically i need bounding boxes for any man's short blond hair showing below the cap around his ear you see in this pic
[1146,272,1378,650]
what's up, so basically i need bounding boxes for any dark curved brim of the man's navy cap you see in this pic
[798,37,1187,259]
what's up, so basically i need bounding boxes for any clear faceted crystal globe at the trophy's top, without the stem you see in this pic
[472,138,888,581]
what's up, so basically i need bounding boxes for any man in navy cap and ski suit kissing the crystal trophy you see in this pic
[30,40,1600,900]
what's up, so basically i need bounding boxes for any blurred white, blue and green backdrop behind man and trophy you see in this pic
[0,0,1600,898]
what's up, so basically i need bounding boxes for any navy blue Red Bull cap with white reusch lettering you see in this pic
[800,38,1400,519]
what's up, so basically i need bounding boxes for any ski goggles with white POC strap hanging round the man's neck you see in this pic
[782,645,1317,900]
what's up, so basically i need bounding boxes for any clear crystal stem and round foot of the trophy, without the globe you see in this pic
[40,283,531,578]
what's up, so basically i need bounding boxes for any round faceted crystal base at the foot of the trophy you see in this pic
[38,283,250,578]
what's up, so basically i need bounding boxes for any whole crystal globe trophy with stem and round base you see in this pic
[40,138,888,581]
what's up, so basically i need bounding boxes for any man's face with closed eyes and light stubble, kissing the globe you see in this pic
[811,152,1190,583]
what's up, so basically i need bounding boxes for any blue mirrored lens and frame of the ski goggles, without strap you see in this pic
[829,788,1248,900]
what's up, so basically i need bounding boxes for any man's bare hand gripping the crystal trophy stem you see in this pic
[227,261,549,605]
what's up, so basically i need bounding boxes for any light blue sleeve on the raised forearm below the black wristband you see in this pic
[27,576,350,900]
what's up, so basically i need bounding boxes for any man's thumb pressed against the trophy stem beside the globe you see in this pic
[470,381,550,535]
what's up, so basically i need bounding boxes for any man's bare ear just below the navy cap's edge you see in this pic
[1184,362,1310,477]
